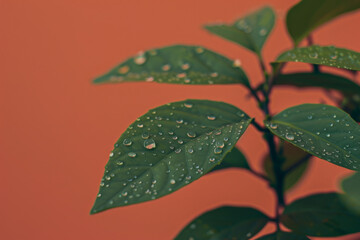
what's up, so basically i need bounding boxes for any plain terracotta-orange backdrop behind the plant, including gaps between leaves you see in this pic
[0,0,360,240]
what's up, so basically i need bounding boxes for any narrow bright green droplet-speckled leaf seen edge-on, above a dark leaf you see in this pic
[275,45,360,71]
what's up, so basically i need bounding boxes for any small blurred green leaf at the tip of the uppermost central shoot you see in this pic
[205,7,275,55]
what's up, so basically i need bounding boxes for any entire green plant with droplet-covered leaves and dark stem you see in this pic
[91,0,360,240]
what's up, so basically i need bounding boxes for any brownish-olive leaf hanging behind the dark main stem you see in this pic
[263,142,311,191]
